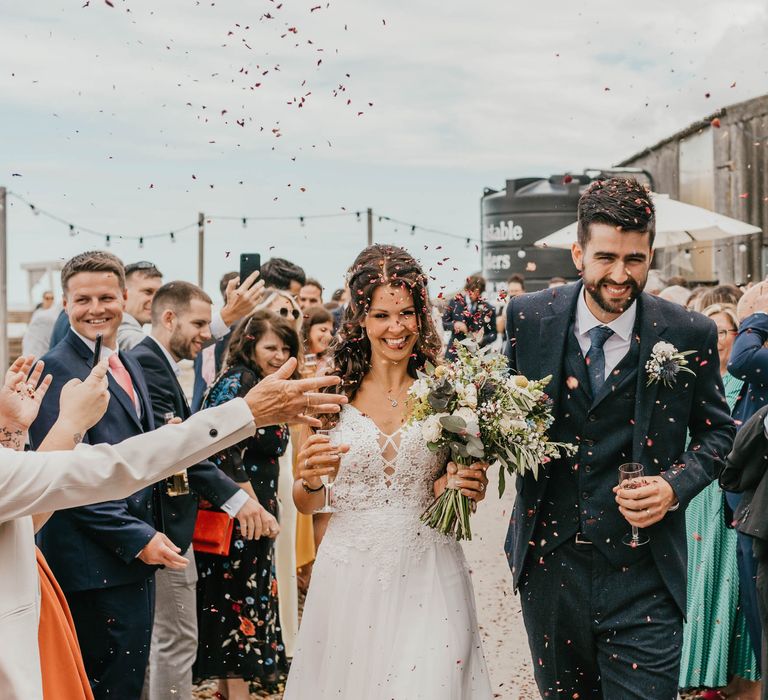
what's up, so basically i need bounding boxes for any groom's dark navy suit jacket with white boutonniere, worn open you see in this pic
[506,282,736,614]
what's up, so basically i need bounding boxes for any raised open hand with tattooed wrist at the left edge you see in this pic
[0,355,52,432]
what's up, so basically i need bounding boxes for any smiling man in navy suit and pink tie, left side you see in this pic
[29,251,188,700]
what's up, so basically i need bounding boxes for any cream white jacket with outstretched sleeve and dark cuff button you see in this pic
[0,399,255,700]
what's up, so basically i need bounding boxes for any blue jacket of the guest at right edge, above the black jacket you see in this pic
[728,313,768,426]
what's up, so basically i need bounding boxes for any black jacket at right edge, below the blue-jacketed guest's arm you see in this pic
[720,406,768,541]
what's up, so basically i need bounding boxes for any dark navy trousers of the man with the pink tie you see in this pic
[66,576,155,700]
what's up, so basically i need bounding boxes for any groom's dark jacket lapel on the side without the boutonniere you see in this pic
[531,282,582,410]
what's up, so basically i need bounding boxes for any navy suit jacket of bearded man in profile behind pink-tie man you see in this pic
[129,337,240,552]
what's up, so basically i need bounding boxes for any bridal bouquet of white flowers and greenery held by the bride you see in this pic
[408,340,575,540]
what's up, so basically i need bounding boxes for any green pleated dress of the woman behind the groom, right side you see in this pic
[680,373,760,688]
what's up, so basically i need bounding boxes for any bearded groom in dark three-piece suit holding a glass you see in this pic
[505,178,735,700]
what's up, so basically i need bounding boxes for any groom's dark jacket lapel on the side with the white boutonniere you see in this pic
[632,292,667,462]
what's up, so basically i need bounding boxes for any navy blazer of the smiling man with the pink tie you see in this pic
[29,330,157,591]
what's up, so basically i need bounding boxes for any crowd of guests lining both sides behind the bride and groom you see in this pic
[12,246,768,700]
